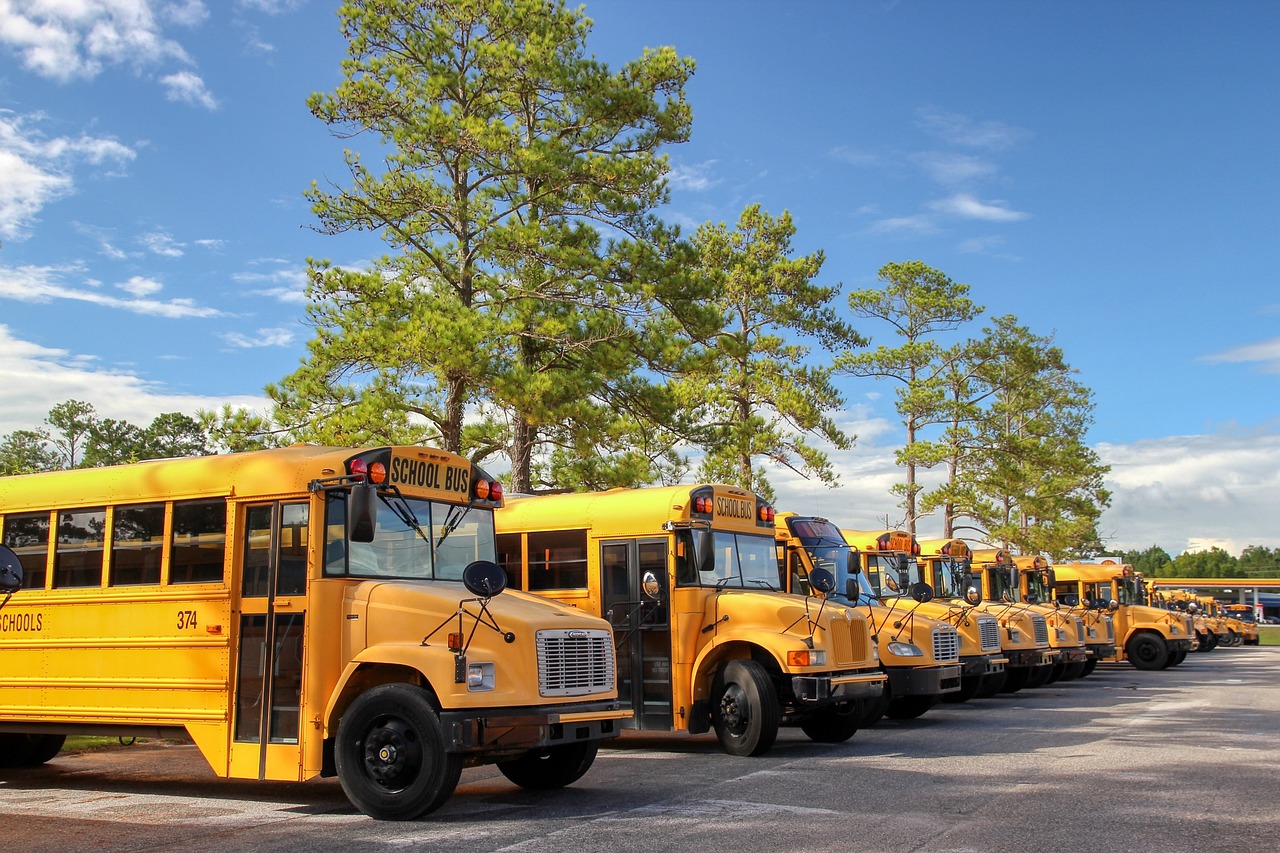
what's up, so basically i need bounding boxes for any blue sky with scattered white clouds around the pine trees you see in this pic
[0,0,1280,555]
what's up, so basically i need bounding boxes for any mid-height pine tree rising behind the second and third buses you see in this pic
[673,205,864,498]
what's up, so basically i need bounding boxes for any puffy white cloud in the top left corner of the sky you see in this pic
[0,0,194,82]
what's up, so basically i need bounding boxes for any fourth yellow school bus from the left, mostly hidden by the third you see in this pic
[841,530,1009,703]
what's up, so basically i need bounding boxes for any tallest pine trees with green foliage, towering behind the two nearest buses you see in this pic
[286,0,692,491]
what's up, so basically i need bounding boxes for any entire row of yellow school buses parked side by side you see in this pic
[0,446,1256,820]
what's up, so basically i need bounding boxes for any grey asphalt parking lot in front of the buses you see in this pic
[0,647,1280,853]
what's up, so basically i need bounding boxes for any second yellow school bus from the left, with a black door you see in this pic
[497,484,884,756]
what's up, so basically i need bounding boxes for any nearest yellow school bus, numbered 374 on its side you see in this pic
[0,446,628,820]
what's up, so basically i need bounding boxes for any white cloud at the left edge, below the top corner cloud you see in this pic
[0,110,137,240]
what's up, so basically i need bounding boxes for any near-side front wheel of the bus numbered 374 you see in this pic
[334,684,462,821]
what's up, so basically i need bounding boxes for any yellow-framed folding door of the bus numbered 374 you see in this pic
[230,501,310,780]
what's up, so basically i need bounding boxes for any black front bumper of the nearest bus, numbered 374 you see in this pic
[440,701,632,753]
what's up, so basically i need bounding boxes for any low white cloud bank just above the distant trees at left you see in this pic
[0,324,268,434]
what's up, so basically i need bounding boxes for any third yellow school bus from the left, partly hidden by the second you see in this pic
[776,512,961,726]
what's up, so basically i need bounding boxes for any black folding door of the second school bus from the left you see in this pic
[600,538,672,731]
